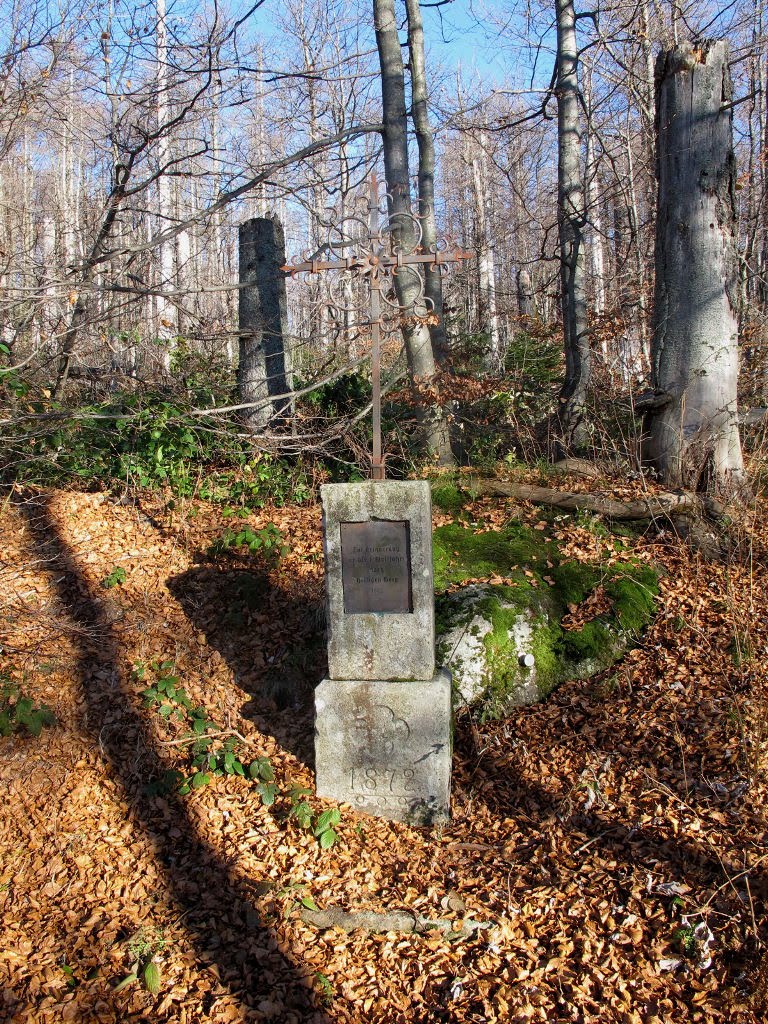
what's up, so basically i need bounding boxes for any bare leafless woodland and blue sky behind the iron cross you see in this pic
[0,2,768,478]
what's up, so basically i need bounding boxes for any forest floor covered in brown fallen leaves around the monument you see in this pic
[0,481,768,1024]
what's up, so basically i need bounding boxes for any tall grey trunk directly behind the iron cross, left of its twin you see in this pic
[374,0,454,465]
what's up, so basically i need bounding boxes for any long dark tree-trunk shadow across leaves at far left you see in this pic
[17,496,328,1024]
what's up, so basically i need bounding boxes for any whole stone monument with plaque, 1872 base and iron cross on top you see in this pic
[283,172,468,824]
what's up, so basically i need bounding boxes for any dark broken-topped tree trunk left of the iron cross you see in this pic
[238,217,291,432]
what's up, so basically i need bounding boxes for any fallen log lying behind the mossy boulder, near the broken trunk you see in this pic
[460,476,724,522]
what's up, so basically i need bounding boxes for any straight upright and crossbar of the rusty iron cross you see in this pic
[281,174,472,480]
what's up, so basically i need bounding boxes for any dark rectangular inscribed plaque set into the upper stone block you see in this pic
[339,519,414,614]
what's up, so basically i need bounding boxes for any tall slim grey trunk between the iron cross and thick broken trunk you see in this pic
[555,0,592,451]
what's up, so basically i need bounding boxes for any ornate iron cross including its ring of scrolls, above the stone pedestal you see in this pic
[281,174,472,480]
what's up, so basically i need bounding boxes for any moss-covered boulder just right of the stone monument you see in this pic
[434,521,658,715]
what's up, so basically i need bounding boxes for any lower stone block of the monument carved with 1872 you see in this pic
[314,669,452,825]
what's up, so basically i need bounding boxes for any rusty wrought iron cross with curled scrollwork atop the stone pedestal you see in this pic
[281,174,472,480]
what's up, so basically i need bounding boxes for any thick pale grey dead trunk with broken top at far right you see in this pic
[644,41,745,495]
